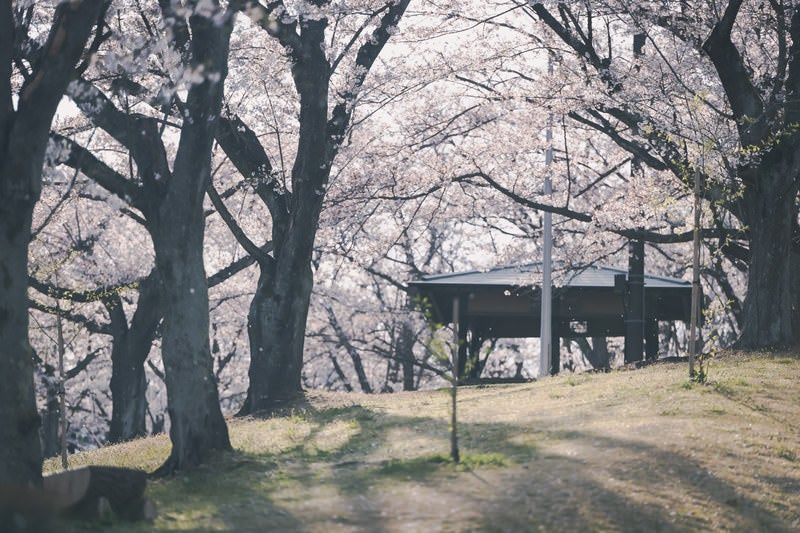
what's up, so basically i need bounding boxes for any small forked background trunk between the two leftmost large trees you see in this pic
[106,271,162,442]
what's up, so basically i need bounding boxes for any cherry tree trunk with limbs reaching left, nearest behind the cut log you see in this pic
[62,2,233,472]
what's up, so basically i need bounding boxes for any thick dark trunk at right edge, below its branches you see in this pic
[739,165,797,348]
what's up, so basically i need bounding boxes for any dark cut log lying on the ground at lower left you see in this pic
[42,466,156,520]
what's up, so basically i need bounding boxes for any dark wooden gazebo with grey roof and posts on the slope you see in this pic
[409,257,692,378]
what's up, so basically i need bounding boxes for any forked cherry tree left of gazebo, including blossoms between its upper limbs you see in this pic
[206,0,409,414]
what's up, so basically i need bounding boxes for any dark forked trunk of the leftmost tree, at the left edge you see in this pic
[0,0,104,485]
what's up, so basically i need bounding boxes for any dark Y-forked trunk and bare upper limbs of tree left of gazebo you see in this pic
[234,4,409,414]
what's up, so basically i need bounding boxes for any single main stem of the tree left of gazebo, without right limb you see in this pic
[239,26,328,414]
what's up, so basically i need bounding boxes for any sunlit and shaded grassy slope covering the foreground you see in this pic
[47,353,800,531]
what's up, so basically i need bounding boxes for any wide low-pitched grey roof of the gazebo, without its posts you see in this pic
[409,262,692,337]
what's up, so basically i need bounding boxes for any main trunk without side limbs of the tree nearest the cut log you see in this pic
[152,8,232,473]
